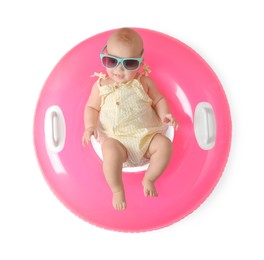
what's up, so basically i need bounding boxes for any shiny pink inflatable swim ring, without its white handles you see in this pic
[34,29,231,232]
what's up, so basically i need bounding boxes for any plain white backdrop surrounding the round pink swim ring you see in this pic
[0,0,264,260]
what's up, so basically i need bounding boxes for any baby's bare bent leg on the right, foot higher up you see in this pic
[142,134,172,197]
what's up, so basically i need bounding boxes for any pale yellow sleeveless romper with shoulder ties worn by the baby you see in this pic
[95,73,167,167]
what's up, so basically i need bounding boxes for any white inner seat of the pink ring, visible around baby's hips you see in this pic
[91,126,174,172]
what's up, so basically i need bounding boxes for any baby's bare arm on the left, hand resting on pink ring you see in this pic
[82,82,101,146]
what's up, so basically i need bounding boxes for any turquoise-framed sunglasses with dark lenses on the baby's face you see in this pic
[100,45,143,71]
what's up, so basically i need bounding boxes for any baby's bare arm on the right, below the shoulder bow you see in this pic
[141,77,178,129]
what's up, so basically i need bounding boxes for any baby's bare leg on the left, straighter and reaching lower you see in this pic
[102,138,127,210]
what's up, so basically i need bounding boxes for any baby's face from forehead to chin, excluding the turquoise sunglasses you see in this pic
[106,42,142,83]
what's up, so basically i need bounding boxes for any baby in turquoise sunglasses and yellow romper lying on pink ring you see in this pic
[82,28,178,210]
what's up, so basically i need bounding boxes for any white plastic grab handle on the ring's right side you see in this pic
[194,102,216,150]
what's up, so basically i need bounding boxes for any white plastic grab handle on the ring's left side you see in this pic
[45,106,66,153]
